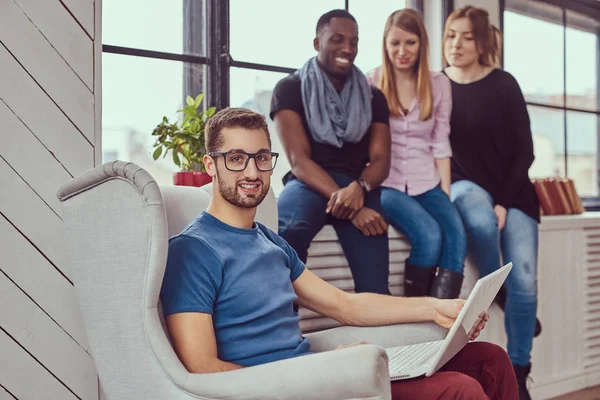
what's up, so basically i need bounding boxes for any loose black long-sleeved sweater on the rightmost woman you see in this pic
[450,69,540,221]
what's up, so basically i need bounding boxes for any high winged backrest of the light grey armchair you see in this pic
[58,161,277,399]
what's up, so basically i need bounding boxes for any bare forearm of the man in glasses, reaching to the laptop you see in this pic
[293,269,464,328]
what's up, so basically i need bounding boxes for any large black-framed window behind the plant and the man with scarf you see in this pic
[102,0,412,194]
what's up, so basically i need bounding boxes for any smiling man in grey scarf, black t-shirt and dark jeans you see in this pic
[271,10,390,294]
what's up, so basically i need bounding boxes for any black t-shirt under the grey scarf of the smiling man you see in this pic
[270,74,390,179]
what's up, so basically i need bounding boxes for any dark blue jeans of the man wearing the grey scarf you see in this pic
[277,173,390,294]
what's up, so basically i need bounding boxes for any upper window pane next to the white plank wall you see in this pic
[102,0,206,55]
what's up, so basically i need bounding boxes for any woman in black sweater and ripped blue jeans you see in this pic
[444,6,539,399]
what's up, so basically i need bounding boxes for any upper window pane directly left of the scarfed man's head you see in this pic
[229,0,344,68]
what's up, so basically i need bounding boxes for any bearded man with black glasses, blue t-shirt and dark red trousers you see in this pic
[160,108,517,399]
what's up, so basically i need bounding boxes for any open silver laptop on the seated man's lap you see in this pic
[386,263,512,381]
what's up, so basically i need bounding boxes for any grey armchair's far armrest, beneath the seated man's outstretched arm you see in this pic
[306,322,448,353]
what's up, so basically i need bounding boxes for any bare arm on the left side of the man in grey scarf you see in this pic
[273,109,339,199]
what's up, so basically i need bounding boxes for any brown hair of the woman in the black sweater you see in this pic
[444,6,501,67]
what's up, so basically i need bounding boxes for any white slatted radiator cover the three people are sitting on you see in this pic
[300,212,600,399]
